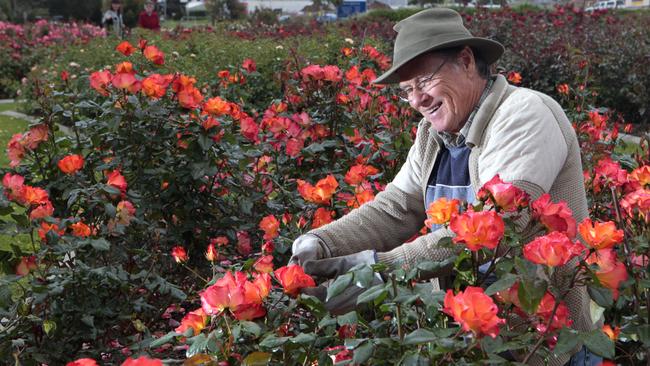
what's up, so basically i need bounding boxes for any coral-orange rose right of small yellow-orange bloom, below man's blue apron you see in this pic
[449,211,505,251]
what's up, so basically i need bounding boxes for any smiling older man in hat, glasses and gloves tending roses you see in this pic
[291,8,598,365]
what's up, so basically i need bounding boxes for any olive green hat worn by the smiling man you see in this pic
[373,8,504,84]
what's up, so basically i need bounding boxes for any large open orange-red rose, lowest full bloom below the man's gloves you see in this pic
[442,286,506,338]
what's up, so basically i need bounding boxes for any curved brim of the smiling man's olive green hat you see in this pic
[373,37,505,84]
